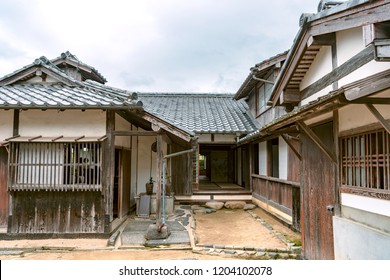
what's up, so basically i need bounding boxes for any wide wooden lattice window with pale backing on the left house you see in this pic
[8,142,102,191]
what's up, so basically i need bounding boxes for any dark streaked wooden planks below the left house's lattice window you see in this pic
[10,191,104,233]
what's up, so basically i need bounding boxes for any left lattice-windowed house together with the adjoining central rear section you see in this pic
[0,52,255,238]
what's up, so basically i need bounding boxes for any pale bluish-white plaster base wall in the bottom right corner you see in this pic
[333,216,390,260]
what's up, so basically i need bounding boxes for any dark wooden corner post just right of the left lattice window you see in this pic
[103,110,115,233]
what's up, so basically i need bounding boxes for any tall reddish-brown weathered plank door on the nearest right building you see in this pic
[301,123,336,260]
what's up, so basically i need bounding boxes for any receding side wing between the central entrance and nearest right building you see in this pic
[234,52,300,231]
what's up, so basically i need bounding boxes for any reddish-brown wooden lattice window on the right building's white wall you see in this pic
[340,130,390,191]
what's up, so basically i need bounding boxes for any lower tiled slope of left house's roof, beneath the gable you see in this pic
[0,84,142,109]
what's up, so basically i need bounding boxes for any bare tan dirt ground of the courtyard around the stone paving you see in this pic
[0,205,300,260]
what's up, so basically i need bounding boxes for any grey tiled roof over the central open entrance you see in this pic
[138,93,256,134]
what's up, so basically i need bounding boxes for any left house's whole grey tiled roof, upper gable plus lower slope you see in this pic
[0,53,142,109]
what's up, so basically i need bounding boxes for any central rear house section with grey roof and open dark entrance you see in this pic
[138,93,256,202]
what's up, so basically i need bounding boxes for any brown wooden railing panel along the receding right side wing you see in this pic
[252,174,301,231]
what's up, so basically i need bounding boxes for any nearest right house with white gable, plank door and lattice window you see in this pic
[236,1,390,259]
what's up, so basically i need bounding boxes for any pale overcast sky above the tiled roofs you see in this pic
[0,0,319,93]
